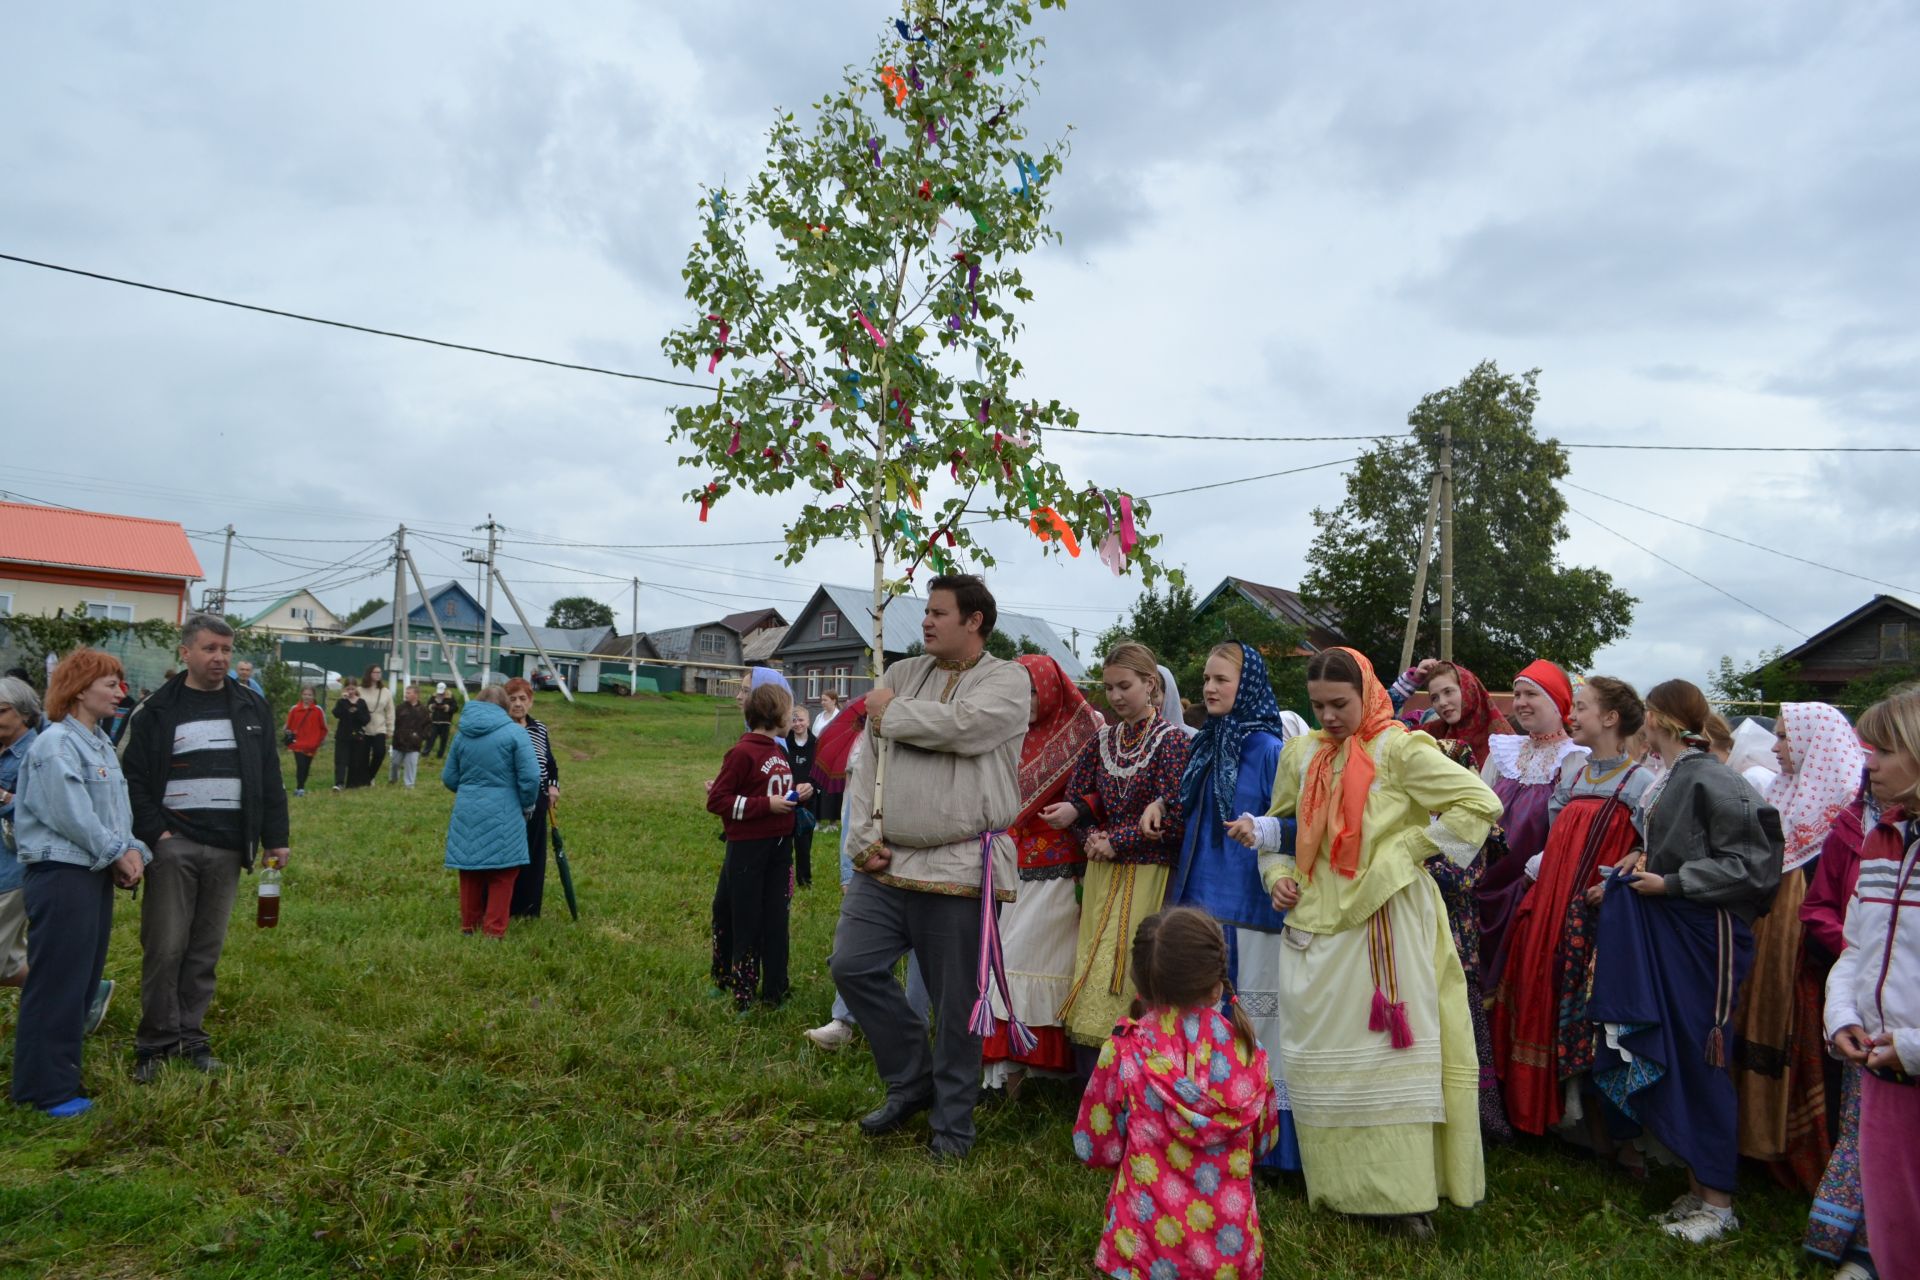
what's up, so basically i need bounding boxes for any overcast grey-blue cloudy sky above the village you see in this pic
[0,0,1920,683]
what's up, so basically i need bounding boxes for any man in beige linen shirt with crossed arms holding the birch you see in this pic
[831,576,1031,1159]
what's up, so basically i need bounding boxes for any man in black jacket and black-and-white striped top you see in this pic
[121,614,288,1084]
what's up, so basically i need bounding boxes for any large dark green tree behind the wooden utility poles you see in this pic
[1300,361,1638,689]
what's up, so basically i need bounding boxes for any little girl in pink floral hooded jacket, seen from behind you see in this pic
[1073,908,1279,1280]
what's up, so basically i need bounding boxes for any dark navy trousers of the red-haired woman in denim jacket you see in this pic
[13,862,113,1107]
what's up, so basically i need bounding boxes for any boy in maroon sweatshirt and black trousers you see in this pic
[707,685,814,1013]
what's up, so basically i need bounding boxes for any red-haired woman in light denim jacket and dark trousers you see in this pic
[13,649,154,1117]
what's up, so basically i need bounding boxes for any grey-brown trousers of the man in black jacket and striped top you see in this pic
[132,837,240,1057]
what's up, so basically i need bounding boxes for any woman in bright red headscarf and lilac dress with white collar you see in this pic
[1478,658,1586,990]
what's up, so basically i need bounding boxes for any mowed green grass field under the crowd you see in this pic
[0,695,1805,1280]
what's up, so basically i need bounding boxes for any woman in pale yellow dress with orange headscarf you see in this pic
[1235,649,1500,1238]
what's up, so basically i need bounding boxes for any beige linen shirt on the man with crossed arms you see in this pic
[843,654,1033,902]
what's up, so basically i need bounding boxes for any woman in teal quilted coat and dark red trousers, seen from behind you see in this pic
[440,687,540,938]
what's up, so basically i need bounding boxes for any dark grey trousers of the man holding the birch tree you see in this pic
[831,875,981,1146]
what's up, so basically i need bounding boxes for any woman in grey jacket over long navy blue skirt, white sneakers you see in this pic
[1586,679,1782,1244]
